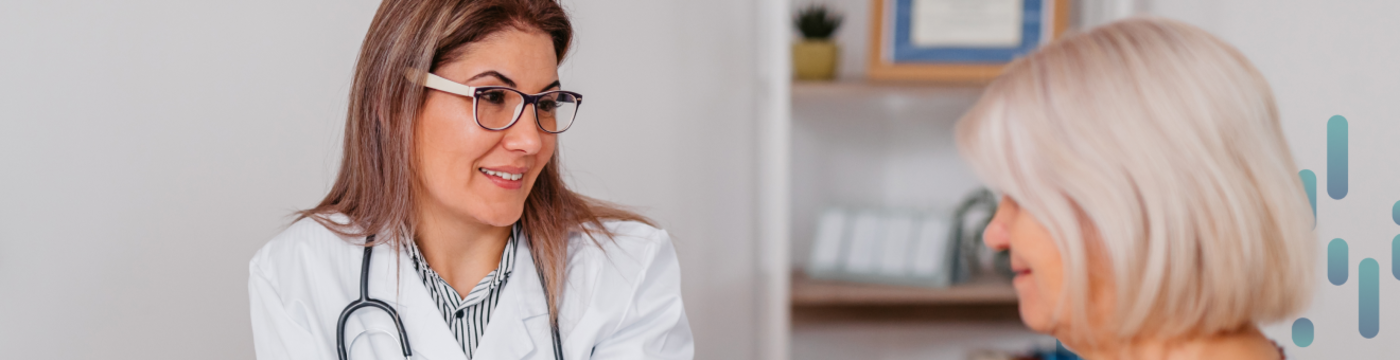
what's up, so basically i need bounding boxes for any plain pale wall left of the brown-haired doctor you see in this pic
[0,0,375,359]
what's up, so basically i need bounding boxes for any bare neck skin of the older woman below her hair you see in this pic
[1065,325,1282,360]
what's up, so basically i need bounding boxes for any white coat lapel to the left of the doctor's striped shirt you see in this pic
[371,245,466,360]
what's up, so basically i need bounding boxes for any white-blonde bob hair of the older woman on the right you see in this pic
[956,18,1315,338]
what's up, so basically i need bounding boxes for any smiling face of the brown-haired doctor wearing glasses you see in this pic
[413,28,559,227]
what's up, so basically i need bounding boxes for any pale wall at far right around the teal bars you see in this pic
[1141,0,1400,359]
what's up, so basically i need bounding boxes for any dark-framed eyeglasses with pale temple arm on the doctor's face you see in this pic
[406,70,584,133]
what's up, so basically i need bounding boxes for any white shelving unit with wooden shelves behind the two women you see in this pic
[757,0,1114,355]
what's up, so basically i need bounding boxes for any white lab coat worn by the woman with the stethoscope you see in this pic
[248,219,694,360]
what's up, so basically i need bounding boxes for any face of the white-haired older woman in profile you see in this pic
[983,196,1113,338]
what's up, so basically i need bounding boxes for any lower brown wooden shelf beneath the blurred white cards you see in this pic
[792,273,1016,307]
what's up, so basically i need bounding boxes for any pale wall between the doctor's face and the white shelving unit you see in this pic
[561,0,759,359]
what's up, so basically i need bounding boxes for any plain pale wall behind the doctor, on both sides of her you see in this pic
[0,0,757,359]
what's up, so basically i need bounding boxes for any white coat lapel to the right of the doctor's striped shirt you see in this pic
[473,238,553,360]
